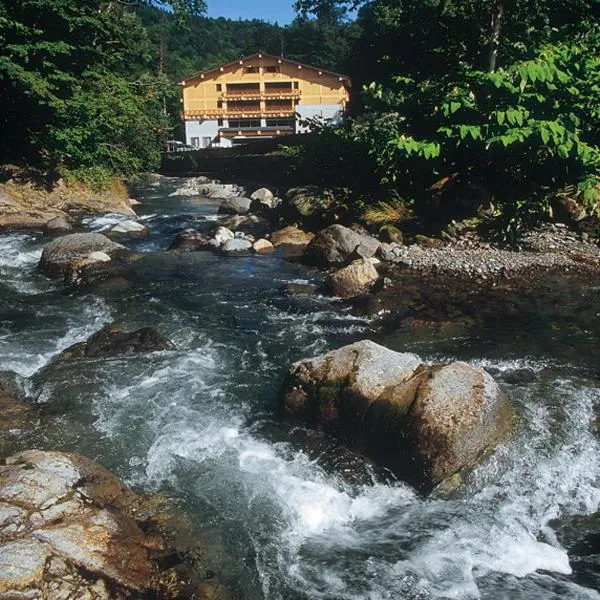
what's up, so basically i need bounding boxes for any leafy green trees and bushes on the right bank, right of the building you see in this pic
[302,0,600,231]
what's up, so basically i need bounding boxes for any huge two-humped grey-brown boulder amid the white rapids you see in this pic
[282,341,513,491]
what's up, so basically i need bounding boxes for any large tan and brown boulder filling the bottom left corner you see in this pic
[0,450,219,600]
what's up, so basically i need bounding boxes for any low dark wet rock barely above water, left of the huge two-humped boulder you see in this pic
[58,324,175,360]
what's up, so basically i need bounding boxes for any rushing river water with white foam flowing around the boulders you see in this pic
[0,176,600,600]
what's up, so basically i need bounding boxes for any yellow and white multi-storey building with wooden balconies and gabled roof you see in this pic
[181,53,350,148]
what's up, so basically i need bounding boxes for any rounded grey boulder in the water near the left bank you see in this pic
[38,233,127,277]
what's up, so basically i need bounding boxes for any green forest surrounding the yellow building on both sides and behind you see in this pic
[0,0,600,228]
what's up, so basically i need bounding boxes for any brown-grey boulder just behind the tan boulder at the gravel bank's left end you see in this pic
[304,225,381,267]
